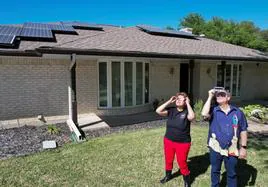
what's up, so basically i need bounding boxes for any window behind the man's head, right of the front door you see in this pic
[217,64,242,96]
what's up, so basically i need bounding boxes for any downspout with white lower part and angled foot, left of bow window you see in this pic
[67,54,83,142]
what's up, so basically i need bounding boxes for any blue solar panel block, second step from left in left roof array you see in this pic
[20,28,54,39]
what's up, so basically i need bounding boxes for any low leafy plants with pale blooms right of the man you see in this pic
[241,104,268,123]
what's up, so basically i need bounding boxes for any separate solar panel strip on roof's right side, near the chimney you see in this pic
[137,25,195,38]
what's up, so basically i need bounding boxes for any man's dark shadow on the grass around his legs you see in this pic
[220,159,258,187]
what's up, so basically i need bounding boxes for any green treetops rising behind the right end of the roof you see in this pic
[180,13,268,52]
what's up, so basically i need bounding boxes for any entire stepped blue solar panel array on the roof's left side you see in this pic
[0,22,103,46]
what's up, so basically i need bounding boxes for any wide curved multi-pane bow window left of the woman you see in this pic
[98,61,149,108]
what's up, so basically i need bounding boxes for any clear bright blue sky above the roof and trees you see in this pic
[0,0,268,29]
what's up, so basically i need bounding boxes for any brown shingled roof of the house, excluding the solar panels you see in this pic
[0,22,268,61]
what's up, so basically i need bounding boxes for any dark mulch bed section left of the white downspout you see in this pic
[0,123,71,159]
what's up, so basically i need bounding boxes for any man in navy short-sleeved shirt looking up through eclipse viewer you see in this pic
[202,89,248,187]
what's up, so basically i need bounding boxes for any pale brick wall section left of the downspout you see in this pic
[0,57,69,120]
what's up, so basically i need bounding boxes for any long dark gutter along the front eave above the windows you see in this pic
[36,47,268,62]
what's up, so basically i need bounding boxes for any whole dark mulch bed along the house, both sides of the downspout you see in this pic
[0,120,166,159]
